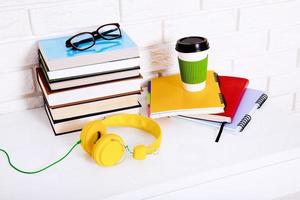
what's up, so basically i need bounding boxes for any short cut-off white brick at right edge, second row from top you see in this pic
[270,24,300,50]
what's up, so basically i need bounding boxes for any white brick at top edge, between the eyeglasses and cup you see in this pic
[121,0,200,21]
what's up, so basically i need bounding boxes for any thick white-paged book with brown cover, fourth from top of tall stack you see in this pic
[37,68,142,107]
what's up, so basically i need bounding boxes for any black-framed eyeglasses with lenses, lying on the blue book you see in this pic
[66,23,122,51]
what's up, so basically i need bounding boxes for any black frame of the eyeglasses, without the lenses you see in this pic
[66,23,122,51]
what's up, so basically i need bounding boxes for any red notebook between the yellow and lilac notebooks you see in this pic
[183,76,249,123]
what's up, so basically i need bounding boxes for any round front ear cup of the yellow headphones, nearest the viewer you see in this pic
[92,134,125,166]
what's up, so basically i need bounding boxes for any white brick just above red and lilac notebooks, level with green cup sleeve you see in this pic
[234,50,297,77]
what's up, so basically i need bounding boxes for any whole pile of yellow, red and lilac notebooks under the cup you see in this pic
[147,71,268,140]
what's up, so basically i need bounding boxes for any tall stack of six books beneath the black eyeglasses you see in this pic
[37,31,142,135]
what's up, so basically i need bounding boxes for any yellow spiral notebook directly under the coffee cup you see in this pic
[150,71,224,118]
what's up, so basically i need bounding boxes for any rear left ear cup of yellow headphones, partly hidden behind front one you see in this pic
[80,120,106,155]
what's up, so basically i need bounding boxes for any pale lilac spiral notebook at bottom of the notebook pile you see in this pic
[176,88,268,132]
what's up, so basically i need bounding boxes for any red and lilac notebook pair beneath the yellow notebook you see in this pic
[178,76,268,133]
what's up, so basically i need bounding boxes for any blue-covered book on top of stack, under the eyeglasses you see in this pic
[38,30,139,71]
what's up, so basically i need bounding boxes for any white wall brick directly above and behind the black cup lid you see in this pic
[164,10,237,42]
